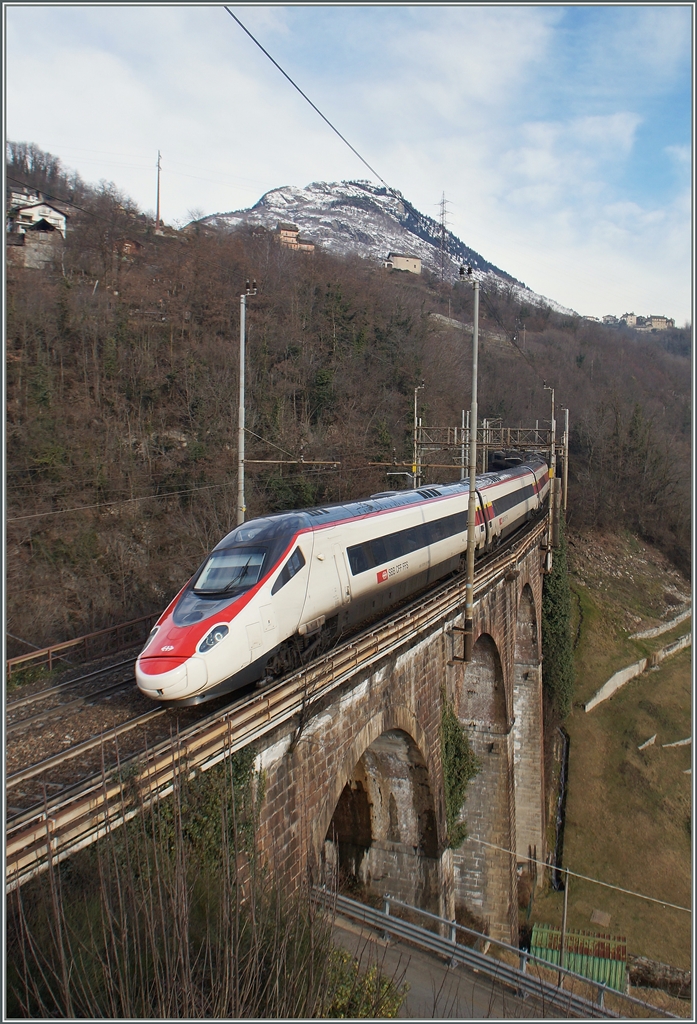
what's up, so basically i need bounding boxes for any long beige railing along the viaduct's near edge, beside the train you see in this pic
[5,517,548,889]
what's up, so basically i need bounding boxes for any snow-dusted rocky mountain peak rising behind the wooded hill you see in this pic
[198,180,573,313]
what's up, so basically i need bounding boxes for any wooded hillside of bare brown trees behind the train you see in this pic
[7,151,691,653]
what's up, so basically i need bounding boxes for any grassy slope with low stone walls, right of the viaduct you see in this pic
[532,530,693,970]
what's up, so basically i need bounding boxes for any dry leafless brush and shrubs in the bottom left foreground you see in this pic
[7,752,404,1020]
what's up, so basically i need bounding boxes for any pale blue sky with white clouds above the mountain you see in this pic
[3,3,694,326]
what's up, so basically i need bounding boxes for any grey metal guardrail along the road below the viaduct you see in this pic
[313,887,681,1020]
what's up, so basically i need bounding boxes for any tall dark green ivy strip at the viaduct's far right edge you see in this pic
[542,518,574,718]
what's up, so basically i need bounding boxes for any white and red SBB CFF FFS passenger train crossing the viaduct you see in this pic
[135,456,550,705]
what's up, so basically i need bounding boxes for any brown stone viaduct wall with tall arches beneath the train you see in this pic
[252,539,546,944]
